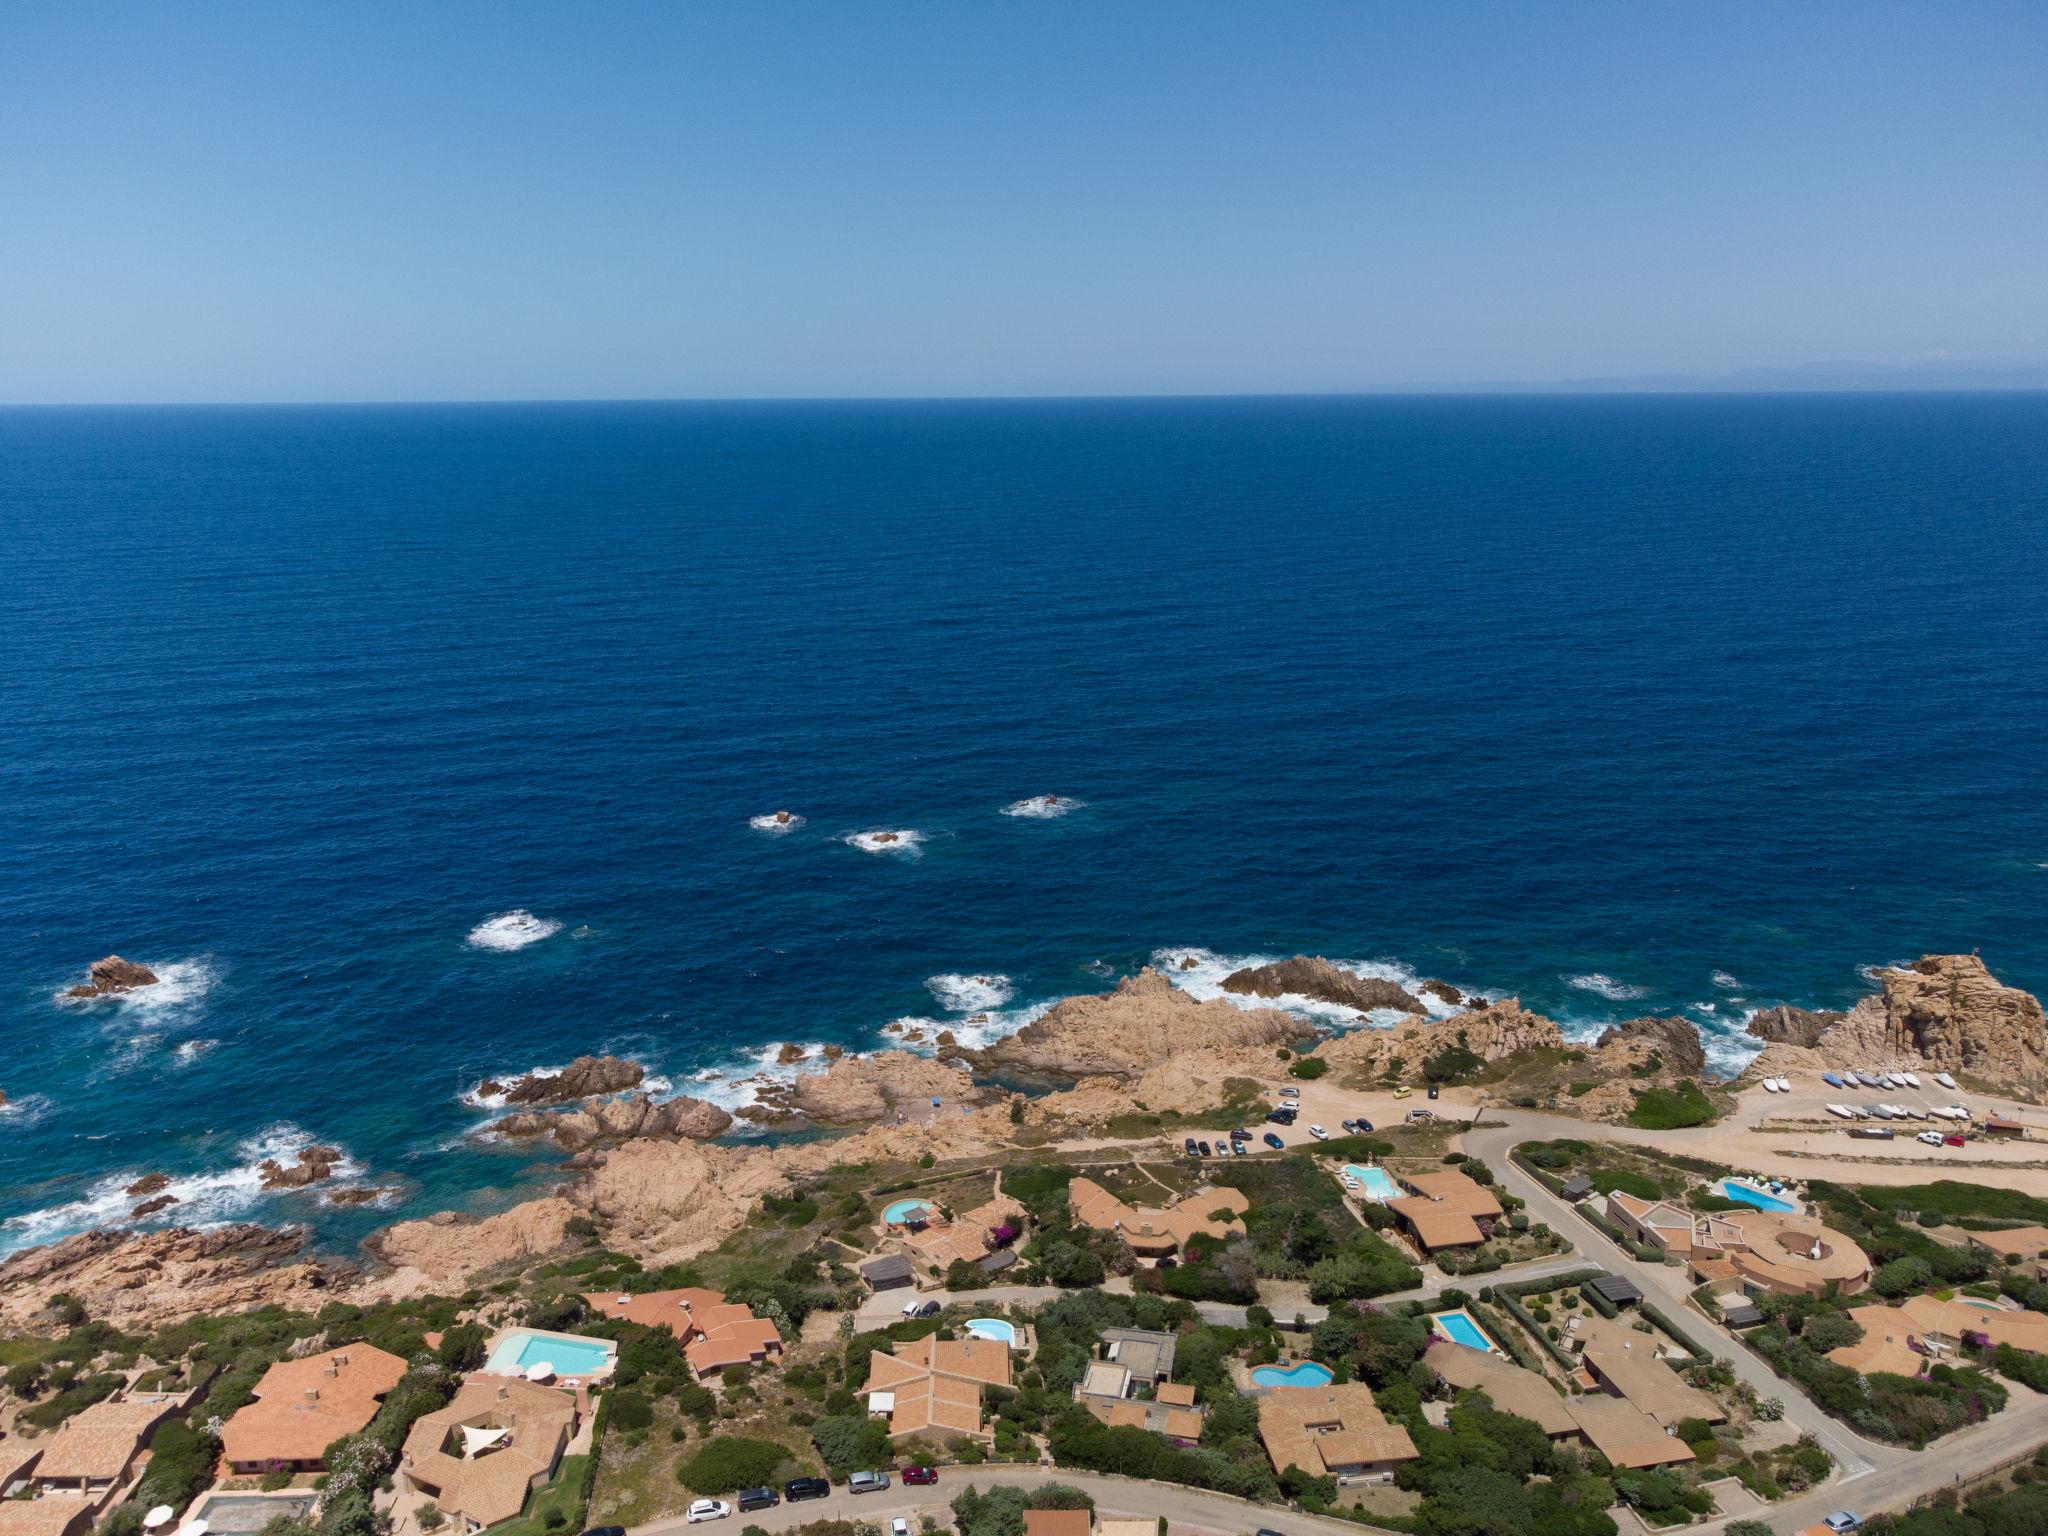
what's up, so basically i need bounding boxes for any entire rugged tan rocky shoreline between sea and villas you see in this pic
[0,954,2048,1327]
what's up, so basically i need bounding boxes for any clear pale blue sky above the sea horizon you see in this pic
[0,0,2048,401]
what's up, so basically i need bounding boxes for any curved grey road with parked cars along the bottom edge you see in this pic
[633,1466,1380,1536]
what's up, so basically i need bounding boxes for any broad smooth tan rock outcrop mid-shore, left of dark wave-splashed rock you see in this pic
[965,967,1315,1077]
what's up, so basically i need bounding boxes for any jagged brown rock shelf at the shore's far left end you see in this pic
[0,1225,332,1329]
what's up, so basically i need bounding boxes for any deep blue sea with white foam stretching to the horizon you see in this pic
[0,395,2048,1249]
